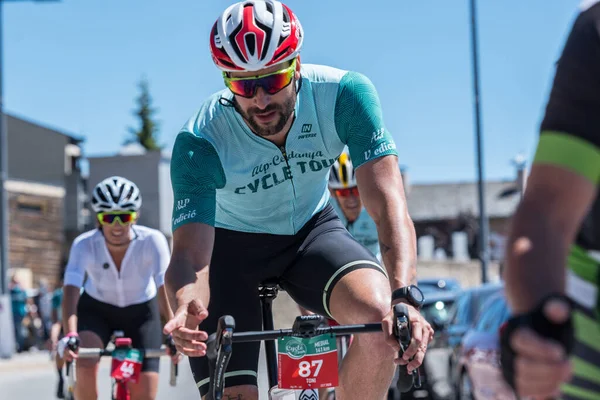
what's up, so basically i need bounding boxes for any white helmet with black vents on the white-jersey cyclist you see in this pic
[92,176,142,213]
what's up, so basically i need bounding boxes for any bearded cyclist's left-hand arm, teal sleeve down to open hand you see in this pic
[163,130,225,356]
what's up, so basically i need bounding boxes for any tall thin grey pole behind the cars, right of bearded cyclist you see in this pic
[471,0,490,283]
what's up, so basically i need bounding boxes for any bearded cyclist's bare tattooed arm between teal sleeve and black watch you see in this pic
[356,156,417,290]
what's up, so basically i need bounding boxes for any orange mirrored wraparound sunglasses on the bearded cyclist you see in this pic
[223,59,296,98]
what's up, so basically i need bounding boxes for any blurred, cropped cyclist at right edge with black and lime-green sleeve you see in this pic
[502,0,600,399]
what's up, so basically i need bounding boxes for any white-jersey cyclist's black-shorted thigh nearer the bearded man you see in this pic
[121,297,162,372]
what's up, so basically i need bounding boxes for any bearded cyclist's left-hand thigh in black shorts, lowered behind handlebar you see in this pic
[189,228,263,396]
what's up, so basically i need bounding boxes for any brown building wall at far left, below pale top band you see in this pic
[6,180,65,287]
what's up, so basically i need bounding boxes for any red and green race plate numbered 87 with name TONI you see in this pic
[277,334,338,389]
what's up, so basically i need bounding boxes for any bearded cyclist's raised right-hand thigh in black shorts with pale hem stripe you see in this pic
[281,209,386,318]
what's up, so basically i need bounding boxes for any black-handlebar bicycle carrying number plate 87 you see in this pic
[206,282,421,400]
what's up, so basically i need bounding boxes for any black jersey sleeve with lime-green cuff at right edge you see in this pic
[534,5,600,184]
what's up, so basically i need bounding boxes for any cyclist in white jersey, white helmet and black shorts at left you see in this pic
[59,176,176,400]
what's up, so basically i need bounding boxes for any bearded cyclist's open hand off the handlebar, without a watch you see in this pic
[163,299,208,357]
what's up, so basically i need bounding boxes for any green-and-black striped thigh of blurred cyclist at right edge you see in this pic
[561,304,600,400]
